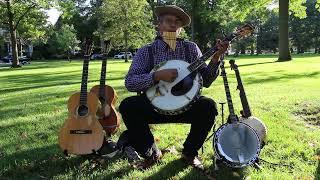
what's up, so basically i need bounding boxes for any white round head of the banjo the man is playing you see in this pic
[146,60,202,115]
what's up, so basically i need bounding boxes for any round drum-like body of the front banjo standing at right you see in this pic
[213,122,260,168]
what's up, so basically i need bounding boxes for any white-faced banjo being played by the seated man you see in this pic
[146,24,254,115]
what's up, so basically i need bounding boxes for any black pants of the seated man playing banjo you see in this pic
[119,95,218,156]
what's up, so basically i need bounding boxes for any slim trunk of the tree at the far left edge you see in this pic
[6,0,21,68]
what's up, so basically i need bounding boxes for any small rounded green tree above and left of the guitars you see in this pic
[54,24,80,62]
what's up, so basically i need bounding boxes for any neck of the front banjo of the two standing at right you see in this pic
[220,60,238,122]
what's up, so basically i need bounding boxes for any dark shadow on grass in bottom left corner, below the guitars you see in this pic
[0,144,133,179]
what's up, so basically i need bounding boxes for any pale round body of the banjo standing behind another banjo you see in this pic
[239,116,267,147]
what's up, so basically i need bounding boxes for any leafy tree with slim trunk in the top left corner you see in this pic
[0,0,50,67]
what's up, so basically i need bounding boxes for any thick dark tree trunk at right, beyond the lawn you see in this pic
[278,0,292,61]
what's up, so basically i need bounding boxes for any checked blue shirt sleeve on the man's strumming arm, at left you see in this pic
[125,47,154,92]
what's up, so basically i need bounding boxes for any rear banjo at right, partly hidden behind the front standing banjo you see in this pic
[229,60,267,146]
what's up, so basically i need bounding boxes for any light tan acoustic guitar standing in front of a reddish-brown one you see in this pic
[59,40,104,155]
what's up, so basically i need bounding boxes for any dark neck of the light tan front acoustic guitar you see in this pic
[80,56,90,105]
